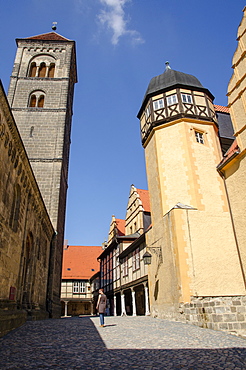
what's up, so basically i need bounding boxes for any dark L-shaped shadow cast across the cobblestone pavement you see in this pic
[0,317,246,370]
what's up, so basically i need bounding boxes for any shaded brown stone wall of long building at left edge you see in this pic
[0,82,54,335]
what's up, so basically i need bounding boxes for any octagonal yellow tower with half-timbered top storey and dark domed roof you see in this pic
[138,63,245,328]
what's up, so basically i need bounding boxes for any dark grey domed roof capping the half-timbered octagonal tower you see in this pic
[145,68,204,96]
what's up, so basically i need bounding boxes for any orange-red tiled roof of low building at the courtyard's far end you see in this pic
[62,245,102,279]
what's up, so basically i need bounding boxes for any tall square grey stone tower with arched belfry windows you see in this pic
[8,32,77,316]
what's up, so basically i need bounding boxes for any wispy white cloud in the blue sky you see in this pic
[98,0,144,45]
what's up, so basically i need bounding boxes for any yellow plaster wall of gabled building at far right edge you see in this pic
[226,7,246,275]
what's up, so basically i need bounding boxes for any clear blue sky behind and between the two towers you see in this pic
[0,0,245,245]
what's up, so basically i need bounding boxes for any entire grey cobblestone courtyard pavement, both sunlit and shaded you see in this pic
[0,317,246,370]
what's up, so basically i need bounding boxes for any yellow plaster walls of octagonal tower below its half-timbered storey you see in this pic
[145,115,245,317]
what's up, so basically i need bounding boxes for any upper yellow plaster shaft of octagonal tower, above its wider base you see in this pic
[148,120,228,215]
